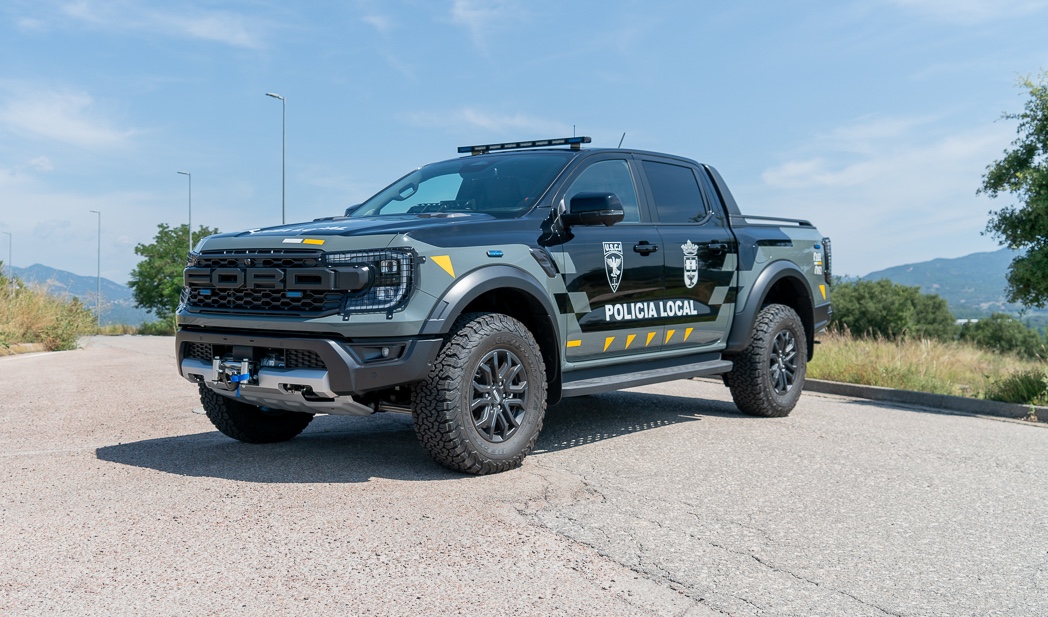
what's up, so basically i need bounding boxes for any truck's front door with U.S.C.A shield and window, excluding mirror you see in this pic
[555,153,664,362]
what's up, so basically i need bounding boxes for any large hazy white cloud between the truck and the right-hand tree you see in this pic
[739,117,1013,274]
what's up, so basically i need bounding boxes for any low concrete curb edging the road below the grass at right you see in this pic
[804,379,1048,422]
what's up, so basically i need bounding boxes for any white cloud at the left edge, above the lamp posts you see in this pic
[0,91,134,148]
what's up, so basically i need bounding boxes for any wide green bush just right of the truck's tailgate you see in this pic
[832,279,957,340]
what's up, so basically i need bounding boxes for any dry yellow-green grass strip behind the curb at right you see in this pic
[808,332,1048,404]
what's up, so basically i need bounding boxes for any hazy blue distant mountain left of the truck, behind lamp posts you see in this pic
[14,264,156,326]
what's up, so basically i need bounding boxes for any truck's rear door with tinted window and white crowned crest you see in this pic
[637,155,738,351]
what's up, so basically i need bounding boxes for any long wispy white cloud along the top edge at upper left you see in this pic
[56,0,268,48]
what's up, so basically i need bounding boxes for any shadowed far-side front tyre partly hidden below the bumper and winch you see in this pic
[200,383,313,443]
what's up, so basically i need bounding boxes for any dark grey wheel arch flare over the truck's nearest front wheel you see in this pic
[421,265,561,404]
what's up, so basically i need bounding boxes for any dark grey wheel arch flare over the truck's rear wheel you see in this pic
[724,261,815,360]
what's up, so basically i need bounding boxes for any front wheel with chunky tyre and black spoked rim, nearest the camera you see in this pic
[411,313,546,475]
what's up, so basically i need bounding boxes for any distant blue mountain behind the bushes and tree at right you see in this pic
[863,248,1048,325]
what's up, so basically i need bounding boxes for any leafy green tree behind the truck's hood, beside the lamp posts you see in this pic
[128,223,218,319]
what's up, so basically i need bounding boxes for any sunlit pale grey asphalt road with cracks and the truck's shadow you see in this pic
[0,336,1048,616]
